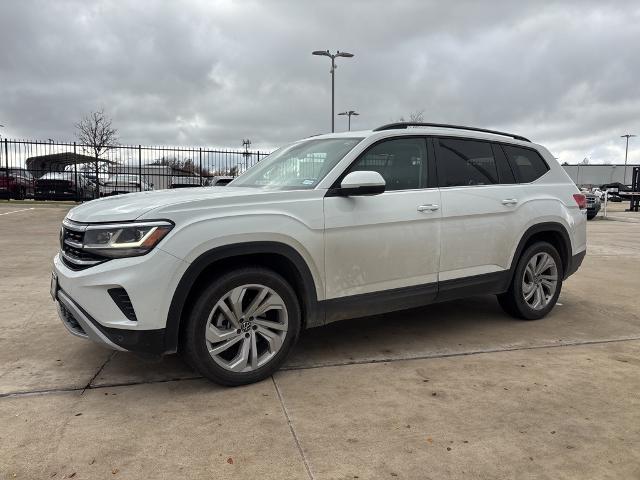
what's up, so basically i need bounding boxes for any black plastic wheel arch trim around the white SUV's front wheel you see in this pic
[165,241,324,353]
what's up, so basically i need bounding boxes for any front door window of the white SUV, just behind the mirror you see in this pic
[349,138,427,190]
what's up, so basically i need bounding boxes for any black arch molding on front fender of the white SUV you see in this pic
[160,242,325,353]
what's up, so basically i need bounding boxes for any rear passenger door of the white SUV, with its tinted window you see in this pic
[434,137,521,284]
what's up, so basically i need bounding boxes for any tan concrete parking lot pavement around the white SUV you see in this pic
[0,204,640,479]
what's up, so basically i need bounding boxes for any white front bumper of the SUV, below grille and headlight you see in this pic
[53,248,188,355]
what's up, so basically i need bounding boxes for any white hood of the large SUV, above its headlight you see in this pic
[67,186,284,222]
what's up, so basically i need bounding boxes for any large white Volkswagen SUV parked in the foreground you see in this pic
[51,123,586,385]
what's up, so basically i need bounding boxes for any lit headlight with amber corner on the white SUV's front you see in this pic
[82,221,173,258]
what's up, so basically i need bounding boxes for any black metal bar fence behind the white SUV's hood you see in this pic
[0,139,269,201]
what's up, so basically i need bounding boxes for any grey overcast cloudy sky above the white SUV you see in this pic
[0,0,640,163]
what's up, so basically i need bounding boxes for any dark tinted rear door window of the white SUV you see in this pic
[438,138,498,187]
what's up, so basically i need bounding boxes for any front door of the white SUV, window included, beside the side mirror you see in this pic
[324,137,440,310]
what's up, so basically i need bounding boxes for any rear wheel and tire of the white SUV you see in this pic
[498,242,564,320]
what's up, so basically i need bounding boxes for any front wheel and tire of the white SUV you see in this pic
[181,267,302,386]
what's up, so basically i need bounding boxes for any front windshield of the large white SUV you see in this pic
[229,138,362,190]
